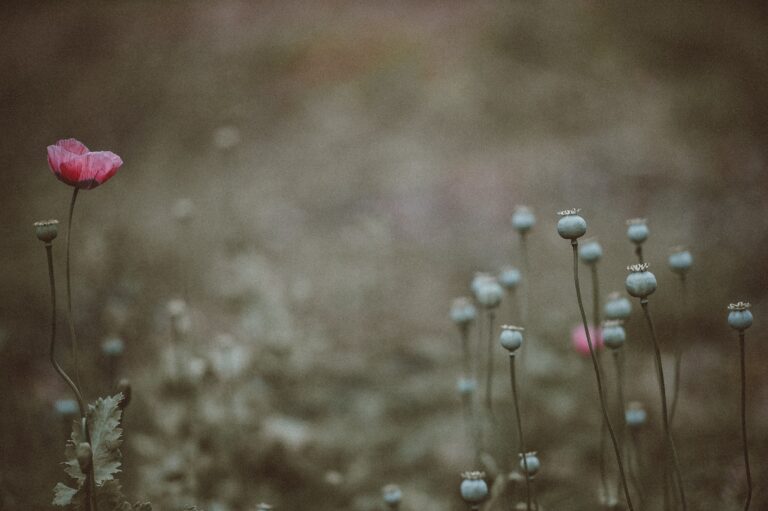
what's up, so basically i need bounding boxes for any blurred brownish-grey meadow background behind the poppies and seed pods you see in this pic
[0,0,768,511]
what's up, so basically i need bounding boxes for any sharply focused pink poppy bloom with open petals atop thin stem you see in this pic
[48,138,123,190]
